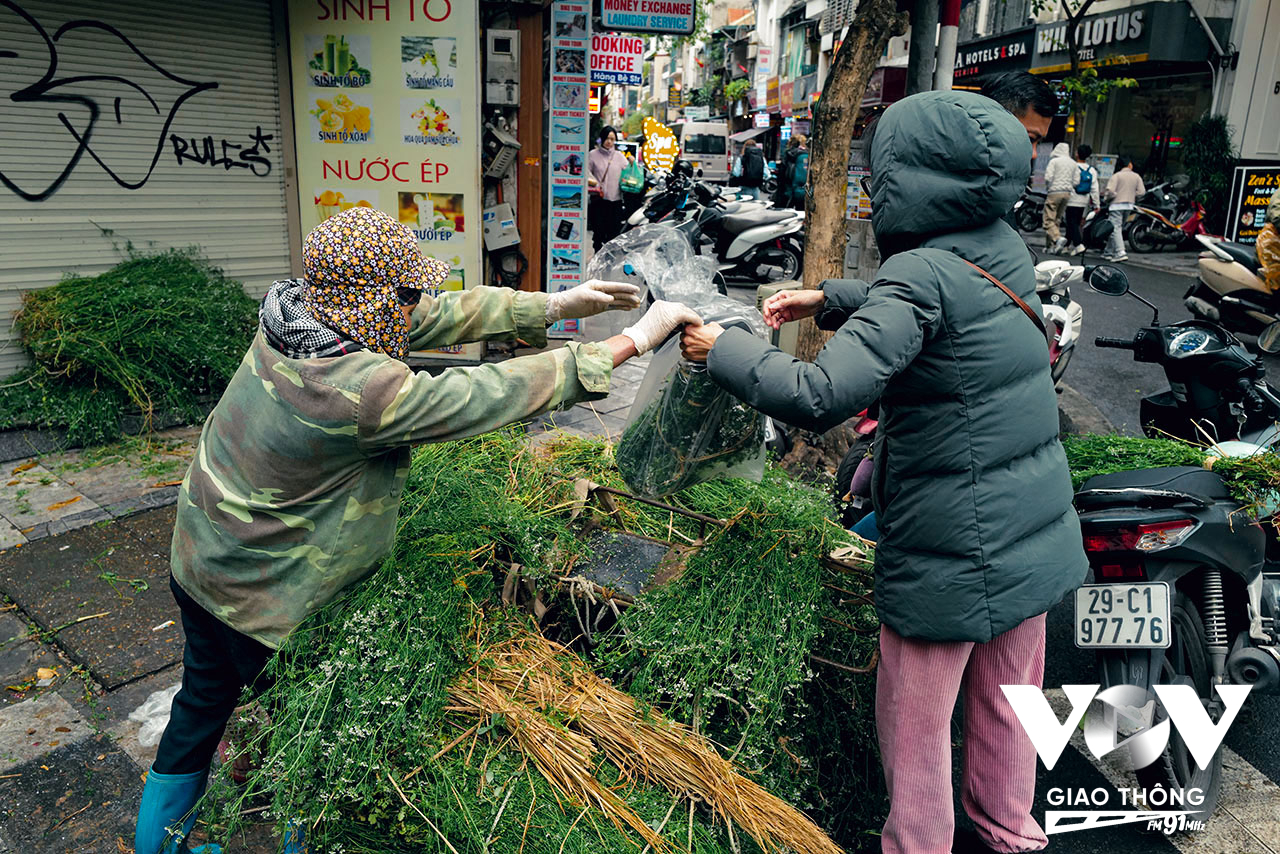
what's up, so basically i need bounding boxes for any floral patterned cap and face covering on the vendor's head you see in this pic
[302,207,449,359]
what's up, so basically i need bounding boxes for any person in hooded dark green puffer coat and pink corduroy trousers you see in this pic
[681,91,1088,854]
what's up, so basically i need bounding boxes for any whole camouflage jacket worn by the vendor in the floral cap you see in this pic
[170,287,613,648]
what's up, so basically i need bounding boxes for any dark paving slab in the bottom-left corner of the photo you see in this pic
[0,735,142,854]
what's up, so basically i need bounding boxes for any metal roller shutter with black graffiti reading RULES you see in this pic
[0,0,293,376]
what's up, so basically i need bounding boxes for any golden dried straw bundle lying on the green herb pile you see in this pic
[453,631,841,854]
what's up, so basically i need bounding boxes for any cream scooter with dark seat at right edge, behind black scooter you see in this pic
[1183,234,1280,334]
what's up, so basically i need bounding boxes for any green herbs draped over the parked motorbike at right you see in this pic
[1062,434,1280,507]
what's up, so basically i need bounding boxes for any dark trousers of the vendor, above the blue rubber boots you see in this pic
[152,577,273,775]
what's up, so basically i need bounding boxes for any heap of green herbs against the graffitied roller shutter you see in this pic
[0,250,257,444]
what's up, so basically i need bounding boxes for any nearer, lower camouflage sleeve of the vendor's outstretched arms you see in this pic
[356,343,613,452]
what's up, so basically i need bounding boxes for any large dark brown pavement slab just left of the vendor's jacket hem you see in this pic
[0,510,182,689]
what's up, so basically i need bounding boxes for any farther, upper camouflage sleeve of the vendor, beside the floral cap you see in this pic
[408,287,547,350]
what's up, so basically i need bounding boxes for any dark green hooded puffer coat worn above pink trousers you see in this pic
[708,92,1087,641]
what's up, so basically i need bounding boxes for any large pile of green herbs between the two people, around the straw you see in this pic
[205,431,886,854]
